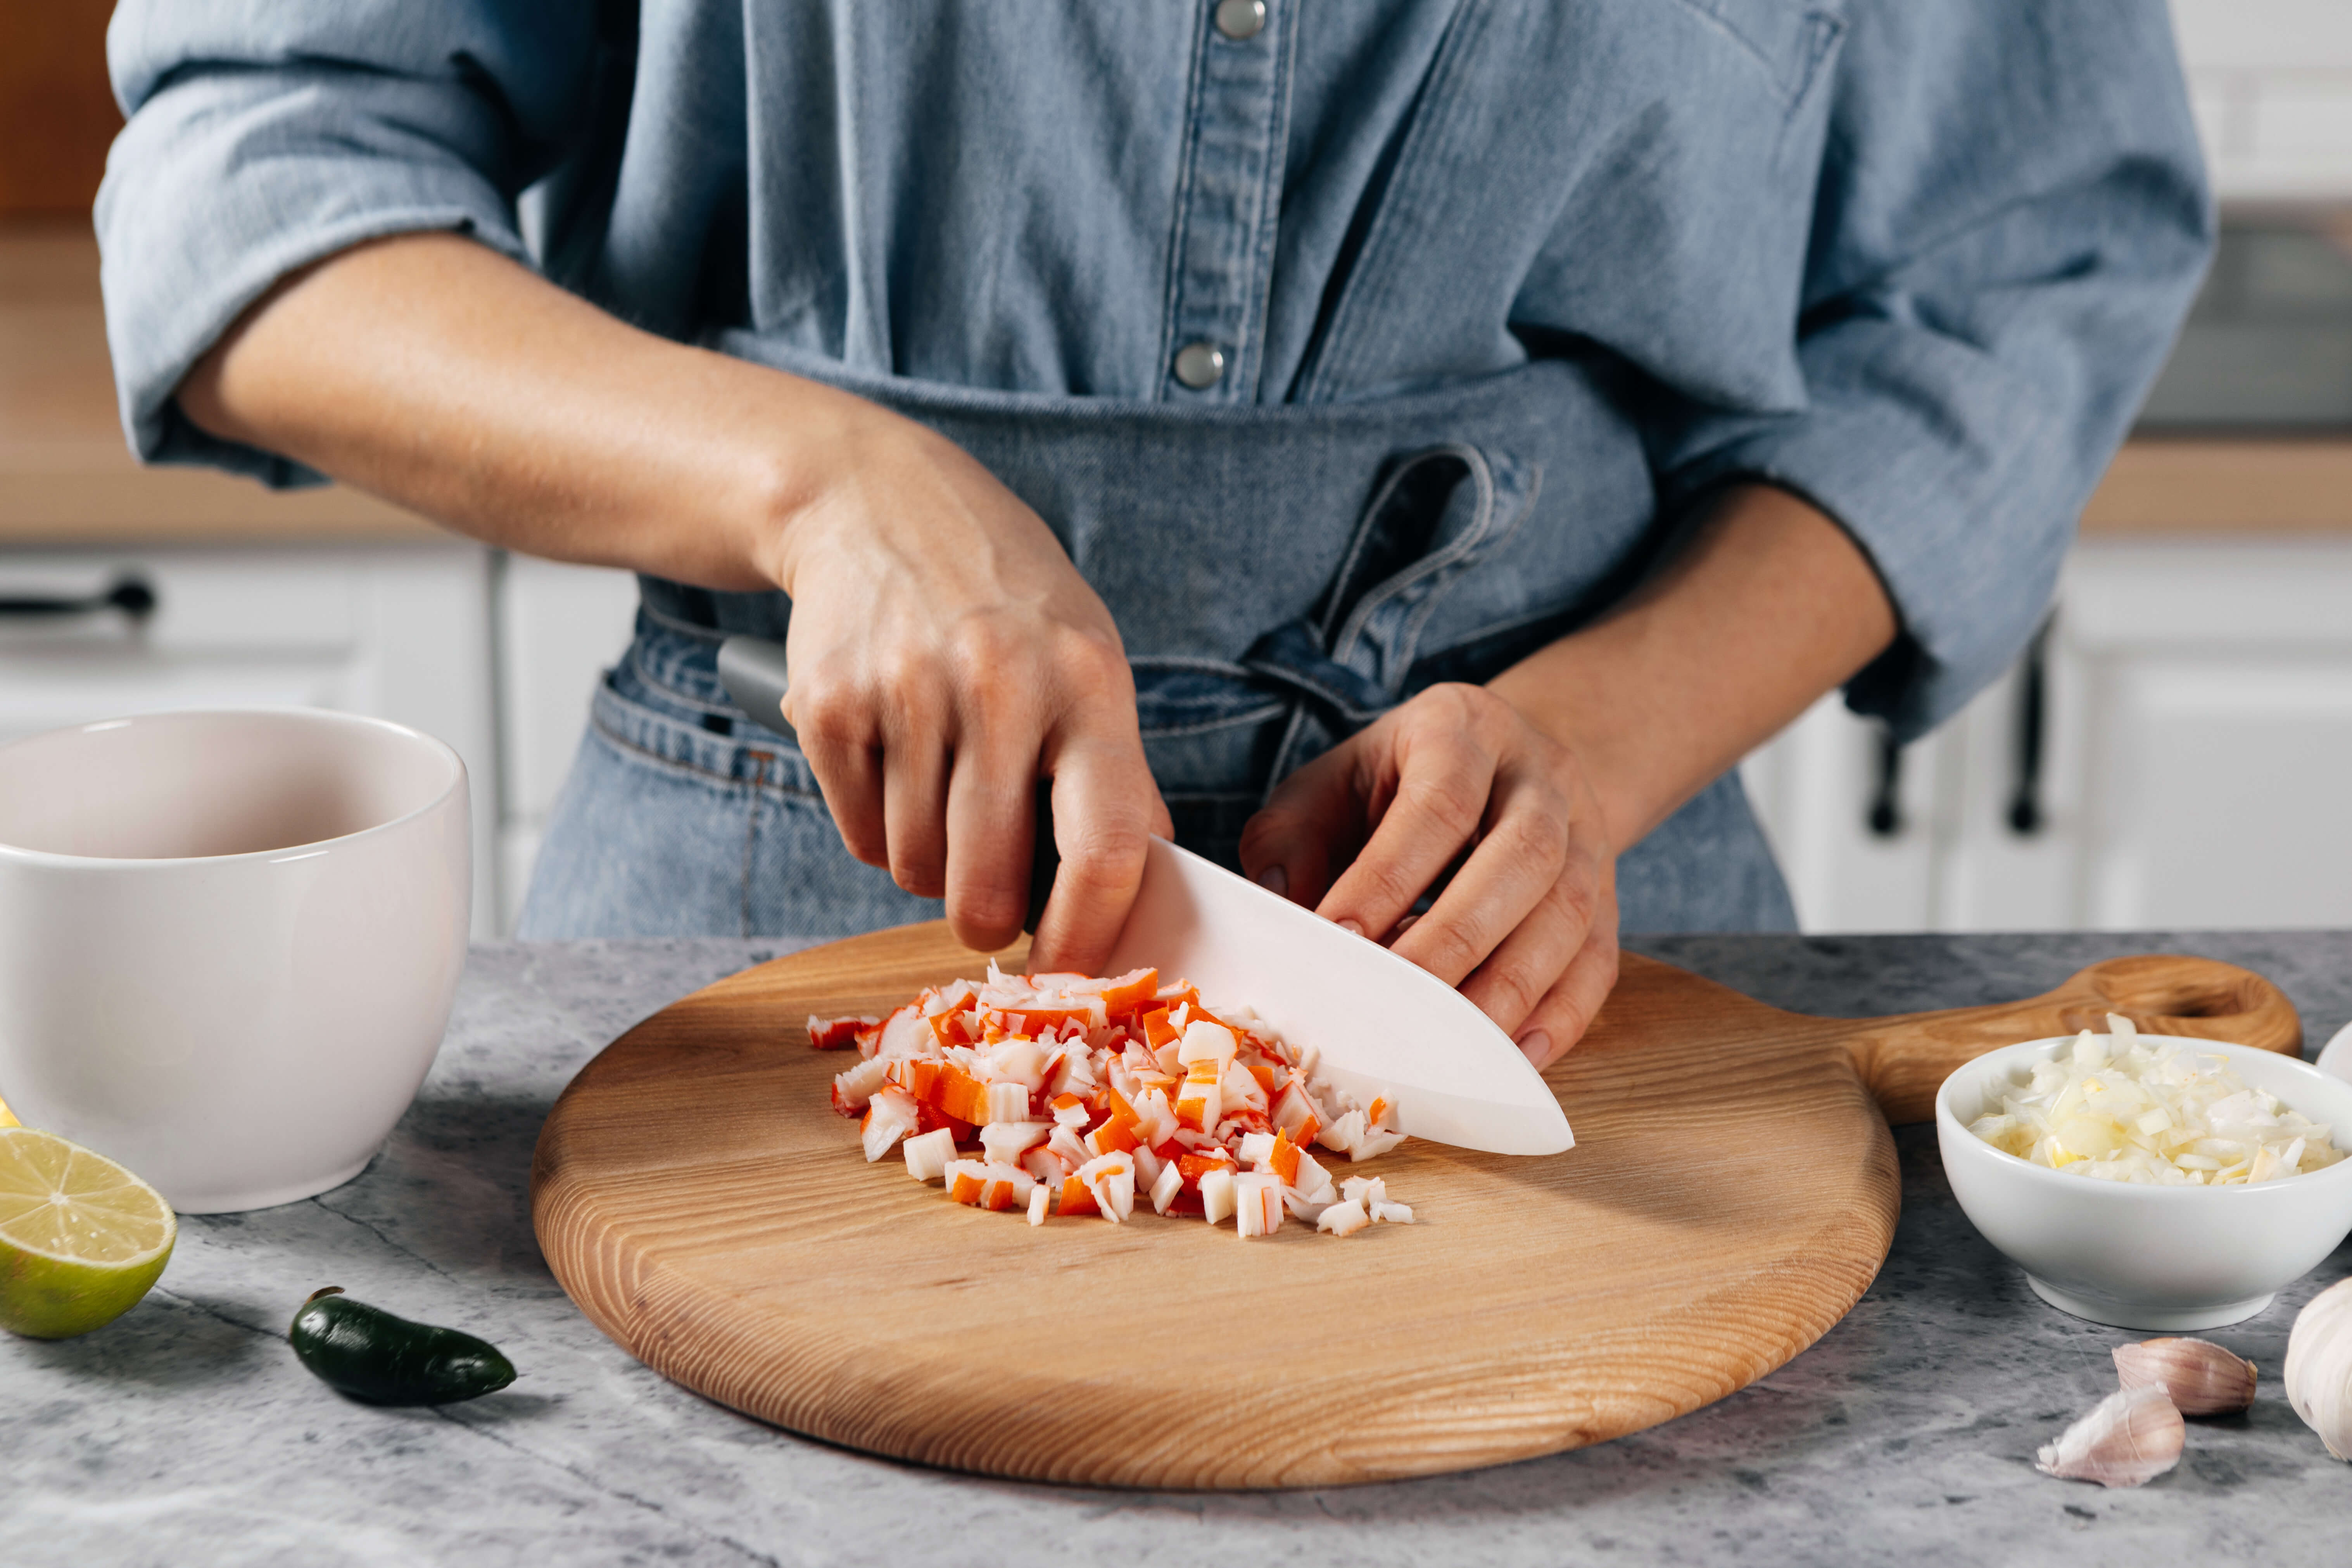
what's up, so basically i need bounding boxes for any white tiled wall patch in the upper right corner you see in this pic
[2171,0,2352,202]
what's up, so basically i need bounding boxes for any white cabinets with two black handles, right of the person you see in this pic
[1745,541,2352,931]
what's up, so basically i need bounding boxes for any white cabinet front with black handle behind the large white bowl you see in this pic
[0,543,499,936]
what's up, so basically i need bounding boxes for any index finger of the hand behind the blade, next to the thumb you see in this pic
[1317,729,1495,945]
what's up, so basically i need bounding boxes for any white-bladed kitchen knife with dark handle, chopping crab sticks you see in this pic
[717,637,1576,1154]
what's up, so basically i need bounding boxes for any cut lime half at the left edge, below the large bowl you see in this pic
[0,1126,179,1340]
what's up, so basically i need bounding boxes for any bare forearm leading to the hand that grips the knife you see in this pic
[179,233,887,590]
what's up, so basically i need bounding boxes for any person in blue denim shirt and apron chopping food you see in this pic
[97,0,2213,1065]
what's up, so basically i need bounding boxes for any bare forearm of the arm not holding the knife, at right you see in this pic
[1491,484,1896,851]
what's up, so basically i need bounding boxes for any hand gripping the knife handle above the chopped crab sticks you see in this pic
[769,409,1174,973]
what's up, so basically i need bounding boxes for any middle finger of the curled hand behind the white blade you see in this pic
[1395,767,1597,987]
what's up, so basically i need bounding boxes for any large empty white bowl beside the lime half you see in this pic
[0,710,470,1213]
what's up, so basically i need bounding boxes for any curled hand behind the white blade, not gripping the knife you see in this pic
[1242,684,1618,1067]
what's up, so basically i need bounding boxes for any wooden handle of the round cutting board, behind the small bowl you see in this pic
[1849,952,2303,1126]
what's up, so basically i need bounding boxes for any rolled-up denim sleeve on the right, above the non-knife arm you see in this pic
[1661,0,2213,738]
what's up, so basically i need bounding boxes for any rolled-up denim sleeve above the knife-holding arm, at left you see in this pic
[97,0,595,484]
